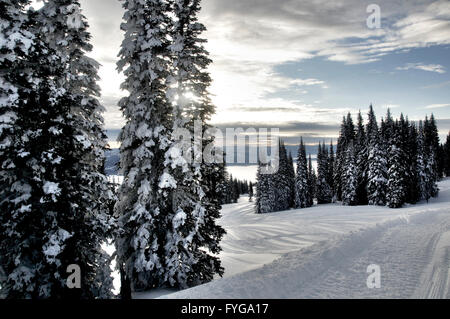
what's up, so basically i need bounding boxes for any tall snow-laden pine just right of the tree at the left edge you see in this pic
[39,0,114,298]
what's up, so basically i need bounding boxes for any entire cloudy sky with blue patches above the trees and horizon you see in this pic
[34,0,450,146]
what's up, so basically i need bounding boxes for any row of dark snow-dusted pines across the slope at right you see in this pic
[256,105,450,214]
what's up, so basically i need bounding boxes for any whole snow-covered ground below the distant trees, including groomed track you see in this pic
[136,179,450,298]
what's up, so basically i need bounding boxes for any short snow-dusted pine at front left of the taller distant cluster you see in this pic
[342,142,358,206]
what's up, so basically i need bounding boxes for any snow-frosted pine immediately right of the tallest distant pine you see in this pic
[386,121,406,208]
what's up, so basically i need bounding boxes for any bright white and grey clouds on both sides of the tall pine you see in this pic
[68,0,450,132]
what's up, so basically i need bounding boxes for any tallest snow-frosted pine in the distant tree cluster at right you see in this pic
[367,105,387,206]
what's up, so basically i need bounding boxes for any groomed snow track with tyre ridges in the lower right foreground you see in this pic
[163,212,450,299]
